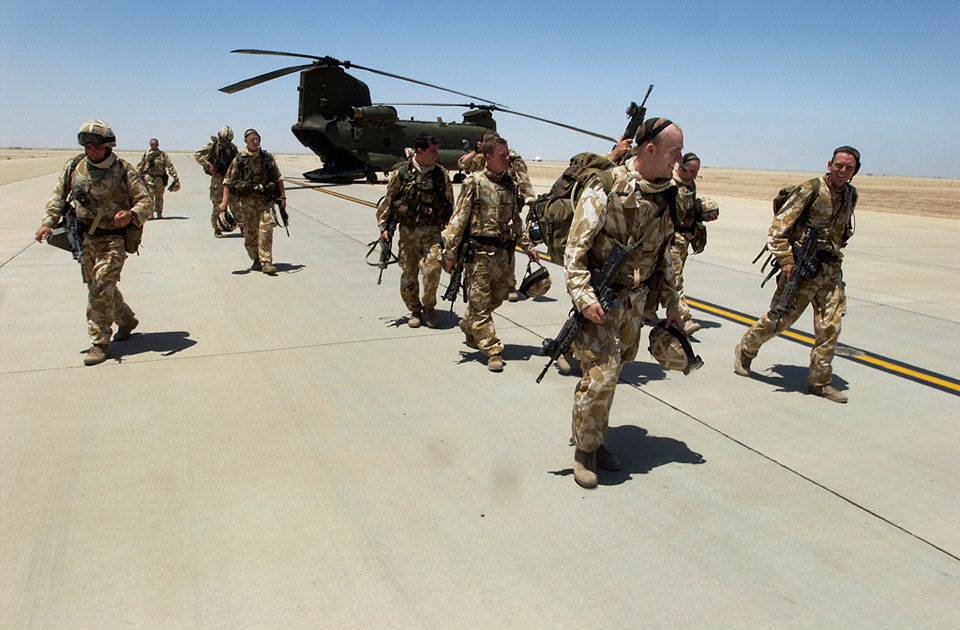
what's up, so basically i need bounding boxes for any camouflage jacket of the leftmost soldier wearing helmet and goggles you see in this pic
[43,153,153,230]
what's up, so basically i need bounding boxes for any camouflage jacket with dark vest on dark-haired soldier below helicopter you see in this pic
[377,158,453,232]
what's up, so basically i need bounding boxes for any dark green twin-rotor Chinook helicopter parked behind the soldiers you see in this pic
[220,49,620,183]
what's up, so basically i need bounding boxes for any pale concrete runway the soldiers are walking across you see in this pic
[0,154,960,629]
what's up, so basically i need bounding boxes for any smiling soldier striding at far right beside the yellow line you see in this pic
[733,146,860,403]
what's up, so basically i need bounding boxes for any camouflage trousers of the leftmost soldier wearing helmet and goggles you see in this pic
[81,235,134,345]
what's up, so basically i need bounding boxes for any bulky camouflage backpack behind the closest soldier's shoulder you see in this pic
[530,152,616,264]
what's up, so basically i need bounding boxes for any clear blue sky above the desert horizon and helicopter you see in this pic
[0,0,960,177]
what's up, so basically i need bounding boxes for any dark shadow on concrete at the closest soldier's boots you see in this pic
[550,424,707,486]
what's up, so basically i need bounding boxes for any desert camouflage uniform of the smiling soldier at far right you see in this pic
[740,176,855,387]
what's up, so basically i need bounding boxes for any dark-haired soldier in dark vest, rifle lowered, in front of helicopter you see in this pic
[377,133,453,328]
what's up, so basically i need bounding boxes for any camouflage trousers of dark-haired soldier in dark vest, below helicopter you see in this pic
[397,224,441,313]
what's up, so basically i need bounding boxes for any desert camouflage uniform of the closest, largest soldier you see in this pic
[563,161,677,452]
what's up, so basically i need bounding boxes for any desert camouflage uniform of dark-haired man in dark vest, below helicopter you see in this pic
[377,158,453,313]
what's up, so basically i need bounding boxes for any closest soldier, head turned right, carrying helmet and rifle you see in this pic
[563,118,683,488]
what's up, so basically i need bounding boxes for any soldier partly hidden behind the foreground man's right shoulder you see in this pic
[664,153,719,336]
